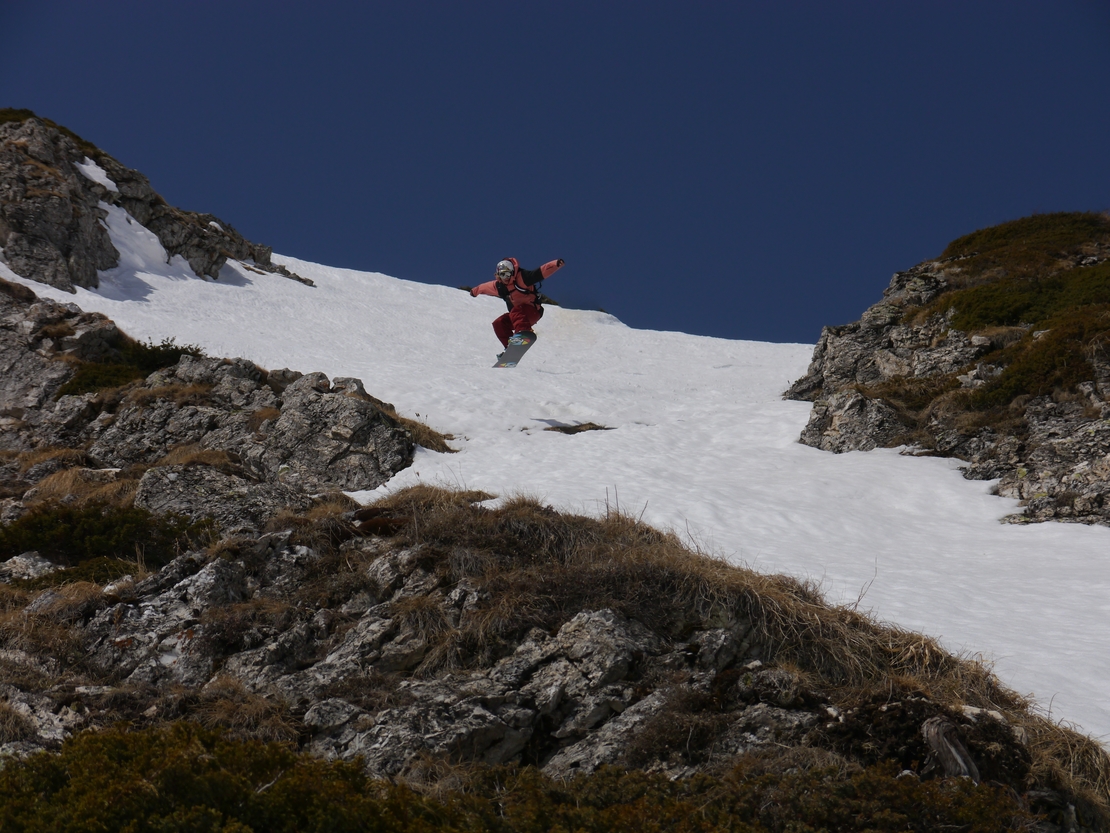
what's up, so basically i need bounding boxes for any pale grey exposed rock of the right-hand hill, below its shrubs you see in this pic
[785,261,1110,524]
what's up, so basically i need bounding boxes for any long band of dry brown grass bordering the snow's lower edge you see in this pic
[364,486,1110,806]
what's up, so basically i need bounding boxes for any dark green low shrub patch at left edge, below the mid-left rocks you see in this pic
[0,504,210,566]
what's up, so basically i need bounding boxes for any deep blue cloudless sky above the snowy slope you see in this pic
[0,0,1110,342]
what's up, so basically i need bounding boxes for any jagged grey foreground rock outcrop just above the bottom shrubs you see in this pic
[0,522,1025,795]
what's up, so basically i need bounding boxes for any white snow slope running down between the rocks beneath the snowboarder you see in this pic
[0,194,1110,739]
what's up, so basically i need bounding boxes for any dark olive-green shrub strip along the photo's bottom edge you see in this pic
[0,723,1032,833]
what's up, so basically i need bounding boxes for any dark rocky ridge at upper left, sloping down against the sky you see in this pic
[0,117,311,291]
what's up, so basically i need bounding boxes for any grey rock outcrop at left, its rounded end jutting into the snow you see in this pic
[0,281,414,532]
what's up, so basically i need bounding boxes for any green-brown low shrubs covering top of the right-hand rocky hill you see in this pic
[864,212,1110,426]
